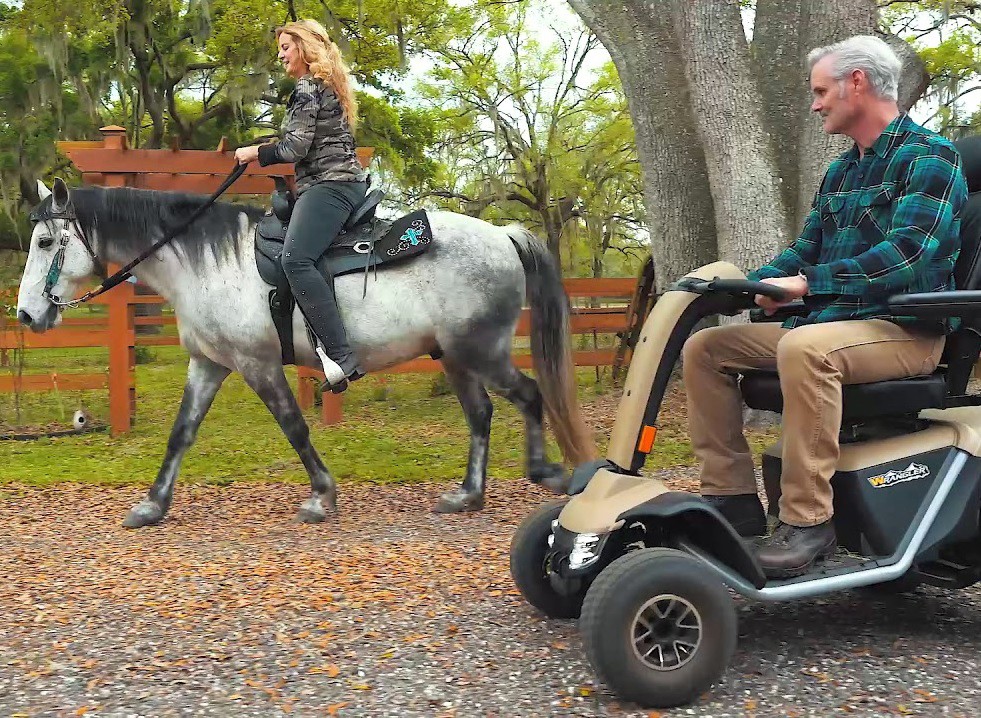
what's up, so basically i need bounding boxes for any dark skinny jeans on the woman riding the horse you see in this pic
[282,182,368,374]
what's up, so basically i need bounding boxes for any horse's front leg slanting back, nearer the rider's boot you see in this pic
[242,364,337,524]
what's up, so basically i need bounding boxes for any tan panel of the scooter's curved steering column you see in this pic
[604,262,746,470]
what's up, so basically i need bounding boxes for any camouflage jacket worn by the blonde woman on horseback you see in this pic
[259,75,365,194]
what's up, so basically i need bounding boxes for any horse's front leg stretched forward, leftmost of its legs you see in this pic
[123,356,230,529]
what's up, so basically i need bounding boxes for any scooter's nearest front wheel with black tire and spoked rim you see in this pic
[579,548,738,708]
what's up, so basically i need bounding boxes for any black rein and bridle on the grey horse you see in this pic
[31,165,248,309]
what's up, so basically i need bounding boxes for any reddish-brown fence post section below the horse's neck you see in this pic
[106,282,136,436]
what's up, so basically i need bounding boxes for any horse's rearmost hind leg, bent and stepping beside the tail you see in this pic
[481,358,569,494]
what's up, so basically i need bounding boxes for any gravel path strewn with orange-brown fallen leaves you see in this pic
[0,472,981,718]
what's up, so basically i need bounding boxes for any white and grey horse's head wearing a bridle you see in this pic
[17,178,99,332]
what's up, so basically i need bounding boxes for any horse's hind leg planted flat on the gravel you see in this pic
[433,359,494,513]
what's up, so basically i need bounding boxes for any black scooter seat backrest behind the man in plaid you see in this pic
[941,136,981,394]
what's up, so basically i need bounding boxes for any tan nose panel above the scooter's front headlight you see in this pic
[559,469,671,534]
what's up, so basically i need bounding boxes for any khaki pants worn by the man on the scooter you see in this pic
[684,319,944,526]
